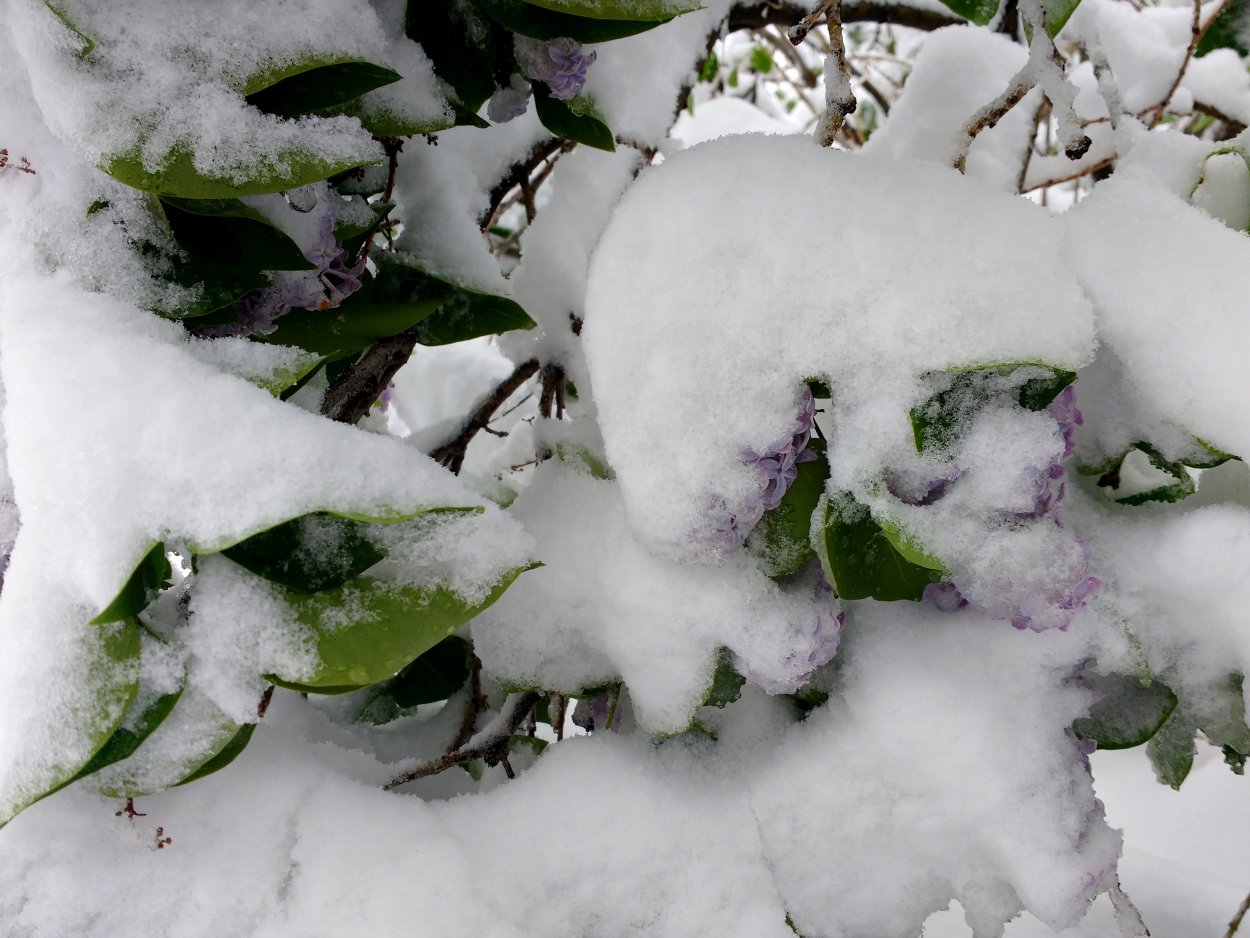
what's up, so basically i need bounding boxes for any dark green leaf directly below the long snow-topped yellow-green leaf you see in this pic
[160,196,316,273]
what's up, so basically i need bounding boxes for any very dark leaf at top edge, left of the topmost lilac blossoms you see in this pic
[404,0,495,113]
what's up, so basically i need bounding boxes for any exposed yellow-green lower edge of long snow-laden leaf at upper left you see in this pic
[100,141,383,199]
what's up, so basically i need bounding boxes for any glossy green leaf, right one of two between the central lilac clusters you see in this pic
[813,493,941,602]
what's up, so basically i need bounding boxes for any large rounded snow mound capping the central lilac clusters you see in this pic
[584,135,1093,562]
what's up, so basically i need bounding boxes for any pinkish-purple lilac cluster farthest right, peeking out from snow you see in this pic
[924,385,1103,632]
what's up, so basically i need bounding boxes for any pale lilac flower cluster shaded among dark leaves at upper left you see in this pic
[200,203,365,338]
